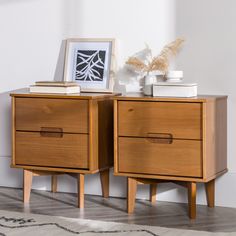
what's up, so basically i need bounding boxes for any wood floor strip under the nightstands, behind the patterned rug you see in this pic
[0,188,236,232]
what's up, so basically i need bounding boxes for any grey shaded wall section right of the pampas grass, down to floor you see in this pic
[175,0,236,207]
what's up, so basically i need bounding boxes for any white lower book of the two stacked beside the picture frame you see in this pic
[30,85,80,94]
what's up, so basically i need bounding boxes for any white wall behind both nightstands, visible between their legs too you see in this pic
[0,0,236,207]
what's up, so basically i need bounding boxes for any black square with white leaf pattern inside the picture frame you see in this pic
[75,50,106,82]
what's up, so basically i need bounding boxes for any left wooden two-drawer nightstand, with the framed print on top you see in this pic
[11,89,118,208]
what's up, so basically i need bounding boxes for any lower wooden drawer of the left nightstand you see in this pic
[15,132,88,169]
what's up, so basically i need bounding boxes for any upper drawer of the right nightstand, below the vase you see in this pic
[118,101,202,139]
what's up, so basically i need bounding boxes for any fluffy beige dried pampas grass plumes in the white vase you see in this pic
[126,38,184,74]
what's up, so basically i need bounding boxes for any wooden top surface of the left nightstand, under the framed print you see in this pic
[10,88,120,100]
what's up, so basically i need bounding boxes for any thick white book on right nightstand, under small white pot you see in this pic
[153,82,197,97]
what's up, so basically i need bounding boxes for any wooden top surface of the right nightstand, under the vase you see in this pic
[114,93,228,102]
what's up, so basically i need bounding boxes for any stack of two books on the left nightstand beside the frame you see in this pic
[30,81,80,94]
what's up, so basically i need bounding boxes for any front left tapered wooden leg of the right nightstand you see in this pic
[127,177,137,213]
